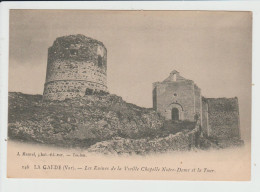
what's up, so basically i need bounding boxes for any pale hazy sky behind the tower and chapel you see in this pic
[9,10,252,139]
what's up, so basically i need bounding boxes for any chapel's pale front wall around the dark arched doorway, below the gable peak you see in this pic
[154,80,195,121]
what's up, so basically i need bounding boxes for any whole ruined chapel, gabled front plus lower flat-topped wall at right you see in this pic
[153,70,240,139]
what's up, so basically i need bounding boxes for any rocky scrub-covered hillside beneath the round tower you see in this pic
[8,92,199,148]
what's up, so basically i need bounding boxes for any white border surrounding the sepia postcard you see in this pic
[0,1,260,192]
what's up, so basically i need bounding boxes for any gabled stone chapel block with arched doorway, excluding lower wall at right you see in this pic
[153,70,202,121]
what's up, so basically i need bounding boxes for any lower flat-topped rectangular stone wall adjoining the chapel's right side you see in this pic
[202,97,240,139]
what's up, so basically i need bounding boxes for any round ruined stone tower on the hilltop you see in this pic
[43,35,107,100]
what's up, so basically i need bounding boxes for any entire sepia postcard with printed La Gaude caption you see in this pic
[7,9,252,181]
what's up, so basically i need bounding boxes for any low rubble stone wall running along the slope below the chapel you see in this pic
[88,130,197,154]
